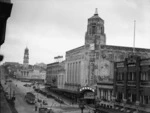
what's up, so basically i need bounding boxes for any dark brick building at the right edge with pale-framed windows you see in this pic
[114,55,150,113]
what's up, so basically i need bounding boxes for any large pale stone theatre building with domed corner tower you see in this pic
[65,10,150,101]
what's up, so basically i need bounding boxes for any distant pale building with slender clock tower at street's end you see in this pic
[16,47,46,82]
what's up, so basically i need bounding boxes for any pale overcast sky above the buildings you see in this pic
[0,0,150,64]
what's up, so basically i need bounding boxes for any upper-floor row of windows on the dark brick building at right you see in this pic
[116,72,150,81]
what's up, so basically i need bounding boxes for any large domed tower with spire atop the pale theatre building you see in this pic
[85,8,106,47]
